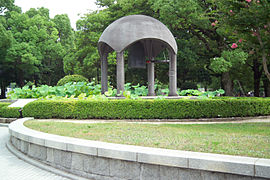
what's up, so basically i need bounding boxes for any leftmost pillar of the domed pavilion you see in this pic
[101,54,108,94]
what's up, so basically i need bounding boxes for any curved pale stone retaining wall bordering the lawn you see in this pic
[9,118,270,180]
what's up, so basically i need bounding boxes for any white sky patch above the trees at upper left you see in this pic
[15,0,98,29]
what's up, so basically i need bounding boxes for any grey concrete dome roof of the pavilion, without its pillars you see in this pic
[98,15,177,54]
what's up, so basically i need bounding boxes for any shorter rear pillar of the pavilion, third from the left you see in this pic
[147,62,155,96]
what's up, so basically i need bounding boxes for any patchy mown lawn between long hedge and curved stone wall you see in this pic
[25,120,270,158]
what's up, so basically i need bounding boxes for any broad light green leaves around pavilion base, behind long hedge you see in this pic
[9,81,224,99]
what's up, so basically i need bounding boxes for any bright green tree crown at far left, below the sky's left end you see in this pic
[6,12,45,86]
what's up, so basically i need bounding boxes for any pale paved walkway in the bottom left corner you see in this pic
[0,127,67,180]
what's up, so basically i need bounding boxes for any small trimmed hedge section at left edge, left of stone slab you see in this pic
[0,103,21,118]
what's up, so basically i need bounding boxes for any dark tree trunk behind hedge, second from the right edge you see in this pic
[252,59,262,97]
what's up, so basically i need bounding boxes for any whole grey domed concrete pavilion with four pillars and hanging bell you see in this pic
[98,15,177,96]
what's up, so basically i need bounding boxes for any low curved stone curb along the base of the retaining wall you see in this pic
[6,141,86,180]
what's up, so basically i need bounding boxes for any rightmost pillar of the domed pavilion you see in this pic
[169,52,178,96]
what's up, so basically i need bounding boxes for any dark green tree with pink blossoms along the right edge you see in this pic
[216,0,270,96]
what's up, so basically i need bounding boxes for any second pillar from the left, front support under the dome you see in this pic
[116,52,125,96]
